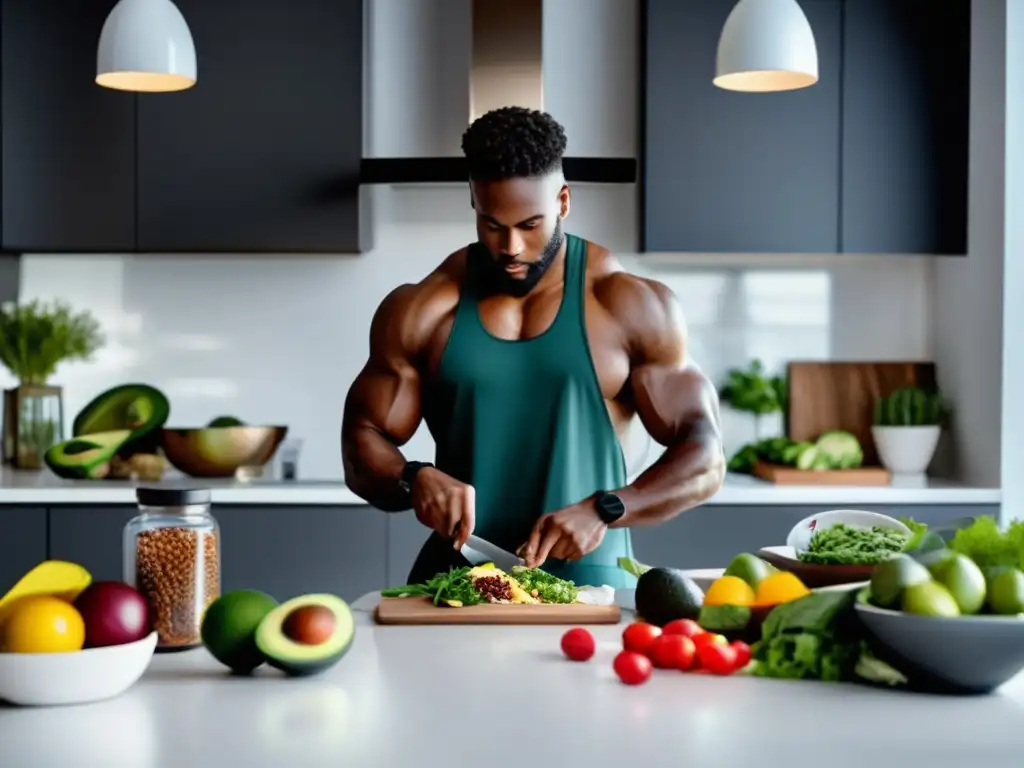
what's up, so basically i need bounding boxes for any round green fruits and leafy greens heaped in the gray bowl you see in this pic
[864,516,1024,617]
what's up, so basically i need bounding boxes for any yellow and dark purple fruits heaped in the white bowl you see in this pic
[0,560,153,653]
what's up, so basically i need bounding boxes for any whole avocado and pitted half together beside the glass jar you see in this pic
[202,590,355,677]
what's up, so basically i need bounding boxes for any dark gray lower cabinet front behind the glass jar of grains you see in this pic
[47,506,387,601]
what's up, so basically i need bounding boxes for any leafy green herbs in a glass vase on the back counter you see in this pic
[0,300,104,469]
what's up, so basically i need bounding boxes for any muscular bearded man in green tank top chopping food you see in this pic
[342,108,725,587]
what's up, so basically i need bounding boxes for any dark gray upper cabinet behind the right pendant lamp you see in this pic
[641,0,971,259]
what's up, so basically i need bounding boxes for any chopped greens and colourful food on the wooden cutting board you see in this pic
[381,563,613,608]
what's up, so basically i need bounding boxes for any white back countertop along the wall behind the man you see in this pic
[0,468,1000,507]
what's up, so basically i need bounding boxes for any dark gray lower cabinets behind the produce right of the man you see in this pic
[632,504,999,568]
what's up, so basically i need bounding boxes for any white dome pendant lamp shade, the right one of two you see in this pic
[714,0,818,91]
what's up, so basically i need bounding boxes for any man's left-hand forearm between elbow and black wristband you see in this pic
[341,426,410,512]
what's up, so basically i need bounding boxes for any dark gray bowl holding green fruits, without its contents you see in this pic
[855,600,1024,693]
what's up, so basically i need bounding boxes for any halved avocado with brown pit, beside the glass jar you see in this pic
[256,594,355,677]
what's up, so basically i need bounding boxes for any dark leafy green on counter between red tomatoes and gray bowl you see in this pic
[750,590,906,685]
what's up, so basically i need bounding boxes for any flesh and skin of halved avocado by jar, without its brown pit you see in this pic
[256,594,355,677]
